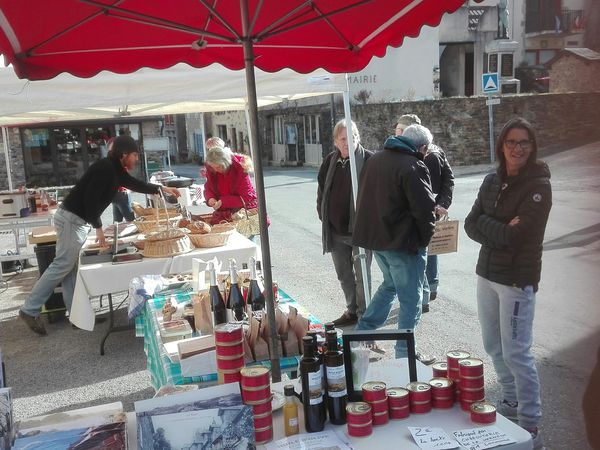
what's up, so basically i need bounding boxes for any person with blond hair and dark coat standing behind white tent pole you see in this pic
[317,119,373,327]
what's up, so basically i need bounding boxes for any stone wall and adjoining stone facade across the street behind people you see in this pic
[259,92,600,166]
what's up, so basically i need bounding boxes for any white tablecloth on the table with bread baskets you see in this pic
[70,232,260,331]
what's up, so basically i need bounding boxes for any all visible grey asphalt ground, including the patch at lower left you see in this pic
[0,142,600,450]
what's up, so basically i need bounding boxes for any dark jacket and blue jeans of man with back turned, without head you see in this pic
[352,136,435,358]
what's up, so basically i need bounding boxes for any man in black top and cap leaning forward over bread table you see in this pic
[19,136,179,335]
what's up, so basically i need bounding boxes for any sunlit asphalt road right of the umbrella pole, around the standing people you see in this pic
[214,143,600,450]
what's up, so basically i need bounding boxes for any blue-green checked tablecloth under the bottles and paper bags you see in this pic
[135,289,321,390]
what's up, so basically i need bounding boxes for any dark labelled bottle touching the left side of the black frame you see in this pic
[323,330,348,425]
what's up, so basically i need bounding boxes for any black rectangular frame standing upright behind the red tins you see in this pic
[342,330,417,401]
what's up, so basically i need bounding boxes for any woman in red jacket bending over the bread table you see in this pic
[204,147,258,223]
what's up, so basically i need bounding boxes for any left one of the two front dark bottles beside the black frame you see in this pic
[300,336,325,433]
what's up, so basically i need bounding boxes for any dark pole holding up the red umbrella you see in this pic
[240,0,281,382]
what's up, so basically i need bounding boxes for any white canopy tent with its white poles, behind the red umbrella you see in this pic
[0,64,370,316]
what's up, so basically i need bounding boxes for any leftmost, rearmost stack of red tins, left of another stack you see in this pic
[214,323,244,384]
